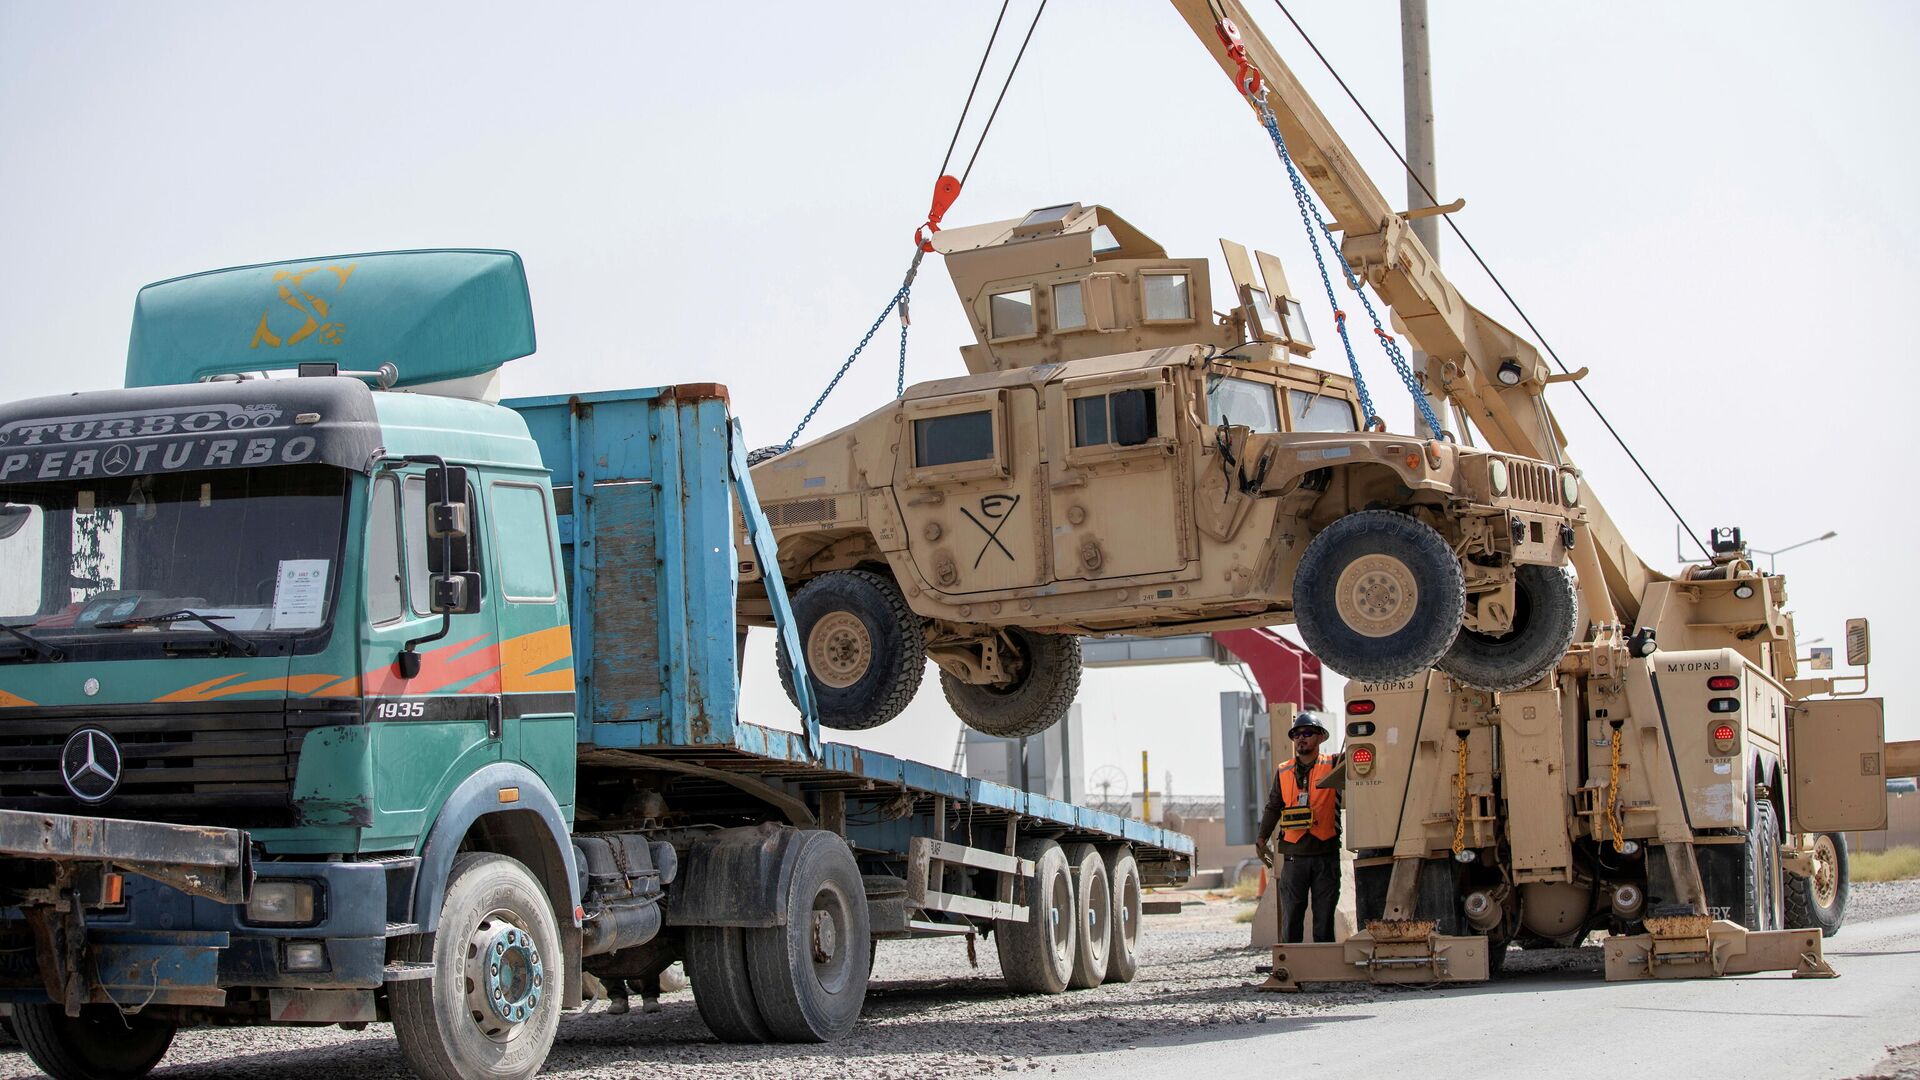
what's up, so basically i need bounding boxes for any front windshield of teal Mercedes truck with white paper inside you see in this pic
[0,465,348,646]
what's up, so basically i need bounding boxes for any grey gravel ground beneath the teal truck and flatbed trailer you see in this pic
[0,880,1920,1080]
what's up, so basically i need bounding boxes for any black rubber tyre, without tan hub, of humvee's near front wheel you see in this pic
[1294,509,1467,682]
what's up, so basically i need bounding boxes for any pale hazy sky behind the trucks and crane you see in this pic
[0,0,1920,794]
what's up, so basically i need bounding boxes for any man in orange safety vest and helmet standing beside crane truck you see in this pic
[1256,713,1340,944]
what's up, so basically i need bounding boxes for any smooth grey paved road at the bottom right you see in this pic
[1048,915,1920,1080]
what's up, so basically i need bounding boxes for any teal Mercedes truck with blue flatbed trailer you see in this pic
[0,250,1192,1080]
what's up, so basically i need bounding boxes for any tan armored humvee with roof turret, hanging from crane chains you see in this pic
[739,204,1582,738]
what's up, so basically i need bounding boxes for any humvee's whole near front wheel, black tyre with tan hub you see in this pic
[1294,509,1467,682]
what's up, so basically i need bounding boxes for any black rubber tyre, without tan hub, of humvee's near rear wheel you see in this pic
[776,571,927,730]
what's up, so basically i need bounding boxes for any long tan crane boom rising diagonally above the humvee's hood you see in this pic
[1173,0,1667,625]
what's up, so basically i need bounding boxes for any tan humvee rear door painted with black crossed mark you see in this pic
[895,386,1048,596]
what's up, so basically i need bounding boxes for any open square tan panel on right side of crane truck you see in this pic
[1788,698,1887,832]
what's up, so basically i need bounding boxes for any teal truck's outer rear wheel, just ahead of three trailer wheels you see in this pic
[747,828,872,1042]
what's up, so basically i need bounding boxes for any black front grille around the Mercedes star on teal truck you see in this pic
[0,701,359,828]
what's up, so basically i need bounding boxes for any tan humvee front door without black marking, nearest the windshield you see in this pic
[1046,367,1192,580]
